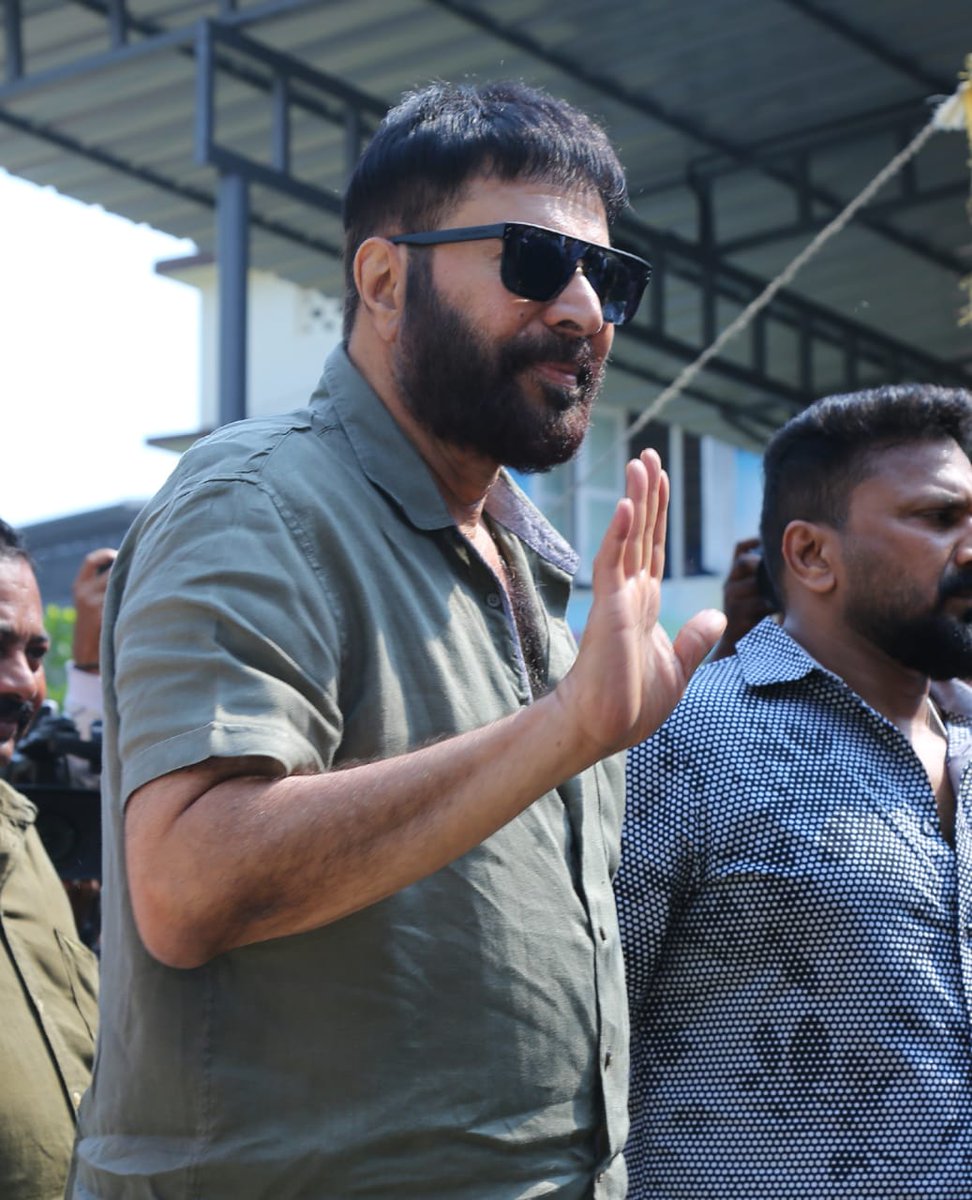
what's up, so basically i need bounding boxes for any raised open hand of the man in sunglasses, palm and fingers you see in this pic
[557,450,725,757]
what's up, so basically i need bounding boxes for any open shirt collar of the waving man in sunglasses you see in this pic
[311,346,577,575]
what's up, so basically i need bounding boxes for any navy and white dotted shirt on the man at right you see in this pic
[616,622,972,1200]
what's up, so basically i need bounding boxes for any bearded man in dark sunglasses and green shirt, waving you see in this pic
[68,84,721,1200]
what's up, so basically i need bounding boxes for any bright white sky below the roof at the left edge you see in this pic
[0,170,199,526]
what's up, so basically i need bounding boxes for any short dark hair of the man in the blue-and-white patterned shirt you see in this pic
[760,383,972,601]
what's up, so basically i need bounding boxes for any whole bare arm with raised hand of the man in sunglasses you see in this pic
[125,451,725,967]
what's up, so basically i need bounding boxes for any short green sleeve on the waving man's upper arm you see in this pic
[109,478,342,800]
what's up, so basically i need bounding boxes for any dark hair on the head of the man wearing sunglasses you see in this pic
[343,82,628,341]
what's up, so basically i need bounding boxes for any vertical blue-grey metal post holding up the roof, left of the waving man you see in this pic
[216,174,250,425]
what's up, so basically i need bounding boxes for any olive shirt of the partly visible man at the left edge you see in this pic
[0,780,97,1200]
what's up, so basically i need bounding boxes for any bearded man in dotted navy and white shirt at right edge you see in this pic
[617,385,972,1200]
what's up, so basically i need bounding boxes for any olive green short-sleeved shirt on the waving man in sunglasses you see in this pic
[73,350,628,1200]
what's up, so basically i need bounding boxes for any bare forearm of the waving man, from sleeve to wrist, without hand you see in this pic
[126,694,605,967]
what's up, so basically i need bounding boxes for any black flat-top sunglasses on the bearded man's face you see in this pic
[389,221,652,325]
